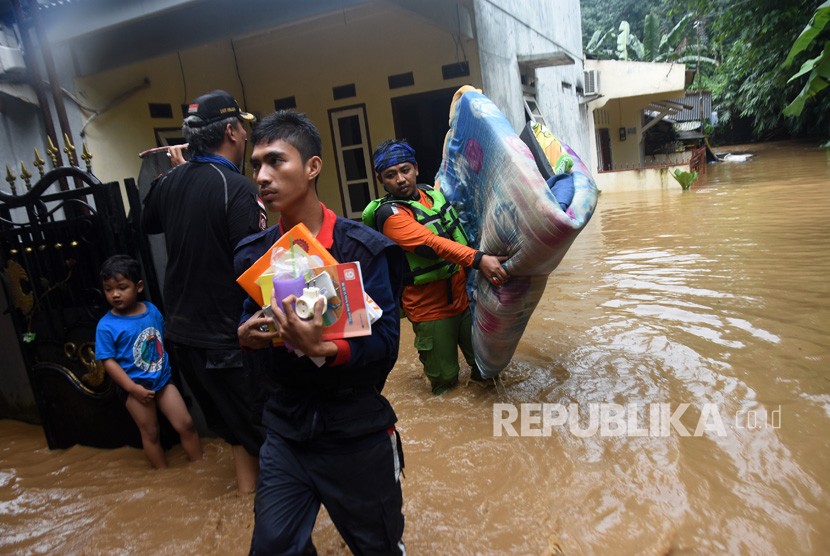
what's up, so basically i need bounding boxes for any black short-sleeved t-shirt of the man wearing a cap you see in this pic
[142,162,265,349]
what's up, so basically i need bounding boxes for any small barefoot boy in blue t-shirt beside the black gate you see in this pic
[95,255,202,469]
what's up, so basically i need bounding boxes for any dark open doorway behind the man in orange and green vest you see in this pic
[392,87,458,184]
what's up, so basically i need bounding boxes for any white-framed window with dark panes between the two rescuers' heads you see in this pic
[329,105,377,218]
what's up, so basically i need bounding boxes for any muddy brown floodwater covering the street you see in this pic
[0,143,830,555]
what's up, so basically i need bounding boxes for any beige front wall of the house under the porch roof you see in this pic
[77,5,481,213]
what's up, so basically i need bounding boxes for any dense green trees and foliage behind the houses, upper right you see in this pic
[581,0,830,139]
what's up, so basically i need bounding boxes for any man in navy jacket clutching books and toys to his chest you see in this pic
[234,111,404,554]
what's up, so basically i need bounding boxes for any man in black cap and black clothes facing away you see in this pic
[142,90,266,492]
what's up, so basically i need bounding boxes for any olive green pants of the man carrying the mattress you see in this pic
[412,308,478,395]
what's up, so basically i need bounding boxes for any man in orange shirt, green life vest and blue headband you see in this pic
[363,140,509,395]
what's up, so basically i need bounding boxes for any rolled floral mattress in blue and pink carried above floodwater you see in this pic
[436,86,597,378]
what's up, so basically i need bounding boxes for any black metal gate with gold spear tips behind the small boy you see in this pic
[0,150,170,449]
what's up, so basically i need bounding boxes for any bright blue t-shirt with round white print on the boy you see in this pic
[95,301,170,392]
